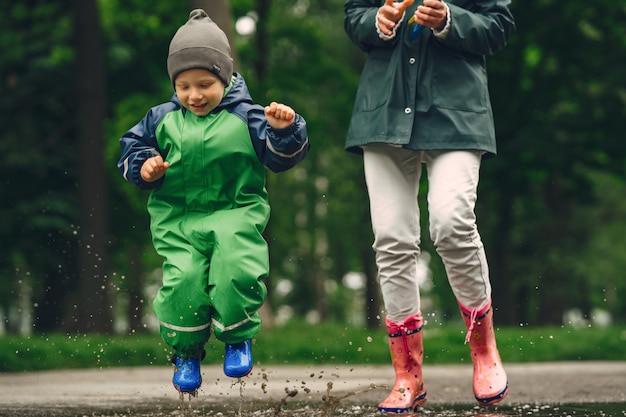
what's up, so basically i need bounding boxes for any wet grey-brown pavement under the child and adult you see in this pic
[0,362,626,417]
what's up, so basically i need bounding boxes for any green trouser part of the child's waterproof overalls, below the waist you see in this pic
[152,206,269,357]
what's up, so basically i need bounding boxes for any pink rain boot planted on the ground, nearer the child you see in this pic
[378,313,426,414]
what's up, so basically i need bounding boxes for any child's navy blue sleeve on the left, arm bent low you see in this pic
[117,102,178,190]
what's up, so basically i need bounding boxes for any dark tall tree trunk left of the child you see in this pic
[68,0,113,333]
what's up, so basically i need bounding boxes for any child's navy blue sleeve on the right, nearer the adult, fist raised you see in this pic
[248,105,311,172]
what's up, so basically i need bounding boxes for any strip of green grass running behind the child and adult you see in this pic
[0,323,626,372]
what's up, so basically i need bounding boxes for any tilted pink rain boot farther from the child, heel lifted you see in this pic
[459,300,509,405]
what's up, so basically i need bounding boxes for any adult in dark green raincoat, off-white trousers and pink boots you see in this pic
[344,0,515,413]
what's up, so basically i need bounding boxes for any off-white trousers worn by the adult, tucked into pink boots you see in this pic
[363,144,491,322]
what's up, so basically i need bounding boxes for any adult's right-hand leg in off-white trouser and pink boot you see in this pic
[425,151,508,405]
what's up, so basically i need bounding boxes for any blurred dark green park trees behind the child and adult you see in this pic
[0,0,626,345]
